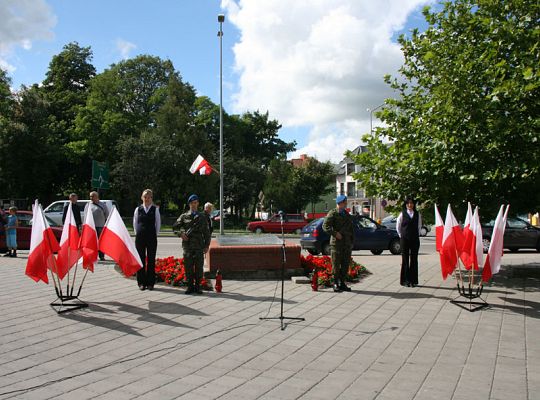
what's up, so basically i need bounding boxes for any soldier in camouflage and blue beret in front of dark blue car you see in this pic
[323,195,354,292]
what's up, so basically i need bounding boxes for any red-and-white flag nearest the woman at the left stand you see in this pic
[99,207,142,276]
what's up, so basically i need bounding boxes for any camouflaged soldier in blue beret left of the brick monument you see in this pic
[175,194,211,294]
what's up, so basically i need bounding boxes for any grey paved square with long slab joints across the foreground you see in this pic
[0,238,540,400]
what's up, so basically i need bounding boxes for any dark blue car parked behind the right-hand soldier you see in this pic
[300,215,401,255]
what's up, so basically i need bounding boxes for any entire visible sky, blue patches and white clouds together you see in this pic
[0,0,431,162]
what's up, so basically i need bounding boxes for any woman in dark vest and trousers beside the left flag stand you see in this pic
[133,189,161,290]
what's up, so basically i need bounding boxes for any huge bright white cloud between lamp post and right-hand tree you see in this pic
[222,0,432,161]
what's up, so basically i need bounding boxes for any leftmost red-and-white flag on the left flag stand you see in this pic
[25,200,60,284]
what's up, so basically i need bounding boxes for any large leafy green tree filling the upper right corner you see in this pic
[356,0,540,217]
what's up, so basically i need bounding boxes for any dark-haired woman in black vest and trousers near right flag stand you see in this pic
[396,197,422,287]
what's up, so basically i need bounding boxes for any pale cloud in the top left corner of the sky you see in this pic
[0,0,56,72]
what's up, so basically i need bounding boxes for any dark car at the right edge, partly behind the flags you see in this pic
[482,217,540,253]
